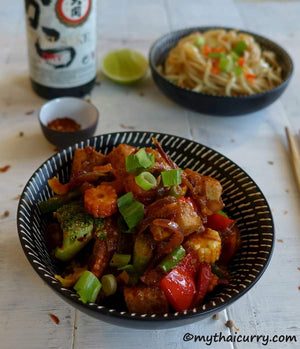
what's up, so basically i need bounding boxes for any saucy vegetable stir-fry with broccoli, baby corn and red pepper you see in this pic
[39,138,240,314]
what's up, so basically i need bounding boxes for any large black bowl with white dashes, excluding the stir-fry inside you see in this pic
[17,132,274,329]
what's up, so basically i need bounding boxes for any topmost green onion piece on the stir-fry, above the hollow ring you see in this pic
[125,148,155,174]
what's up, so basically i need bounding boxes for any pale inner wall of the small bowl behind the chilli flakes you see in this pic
[39,97,99,129]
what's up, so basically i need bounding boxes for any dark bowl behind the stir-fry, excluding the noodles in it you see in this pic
[149,27,293,116]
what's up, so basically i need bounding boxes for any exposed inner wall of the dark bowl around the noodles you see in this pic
[149,27,293,93]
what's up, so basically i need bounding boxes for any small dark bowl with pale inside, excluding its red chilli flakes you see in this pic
[39,97,99,148]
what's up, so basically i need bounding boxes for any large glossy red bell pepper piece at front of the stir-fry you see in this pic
[160,253,200,312]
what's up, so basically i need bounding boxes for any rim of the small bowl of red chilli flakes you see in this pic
[38,96,100,137]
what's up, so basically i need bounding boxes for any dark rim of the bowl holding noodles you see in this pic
[148,26,294,100]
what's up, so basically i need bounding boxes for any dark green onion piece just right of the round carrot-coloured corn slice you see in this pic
[117,192,144,229]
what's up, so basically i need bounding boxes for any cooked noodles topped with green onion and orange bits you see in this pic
[159,29,282,96]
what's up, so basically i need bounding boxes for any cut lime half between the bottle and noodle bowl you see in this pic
[102,49,148,84]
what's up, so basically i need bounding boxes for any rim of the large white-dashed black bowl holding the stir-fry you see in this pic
[17,130,275,329]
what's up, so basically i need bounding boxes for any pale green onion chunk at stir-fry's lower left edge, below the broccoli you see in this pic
[74,270,101,303]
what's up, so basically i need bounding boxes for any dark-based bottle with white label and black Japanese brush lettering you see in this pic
[25,0,97,99]
